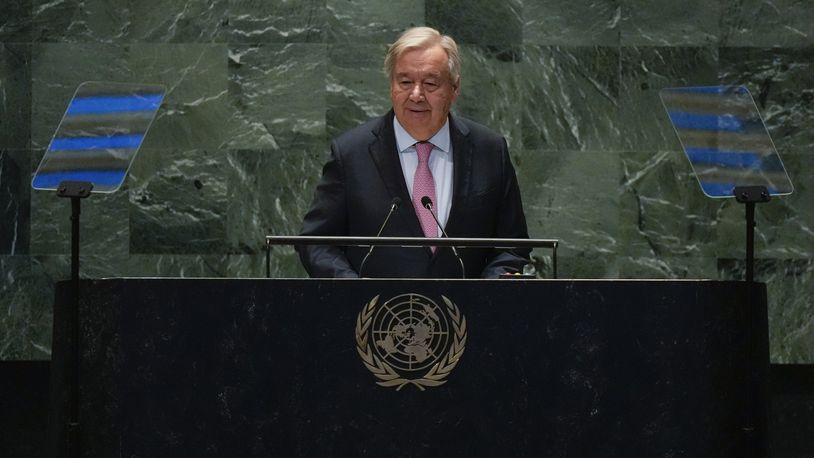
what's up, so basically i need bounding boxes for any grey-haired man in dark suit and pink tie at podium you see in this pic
[297,27,529,278]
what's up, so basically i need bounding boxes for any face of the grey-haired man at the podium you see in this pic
[390,46,459,141]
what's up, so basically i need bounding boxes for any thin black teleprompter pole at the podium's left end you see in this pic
[57,181,93,458]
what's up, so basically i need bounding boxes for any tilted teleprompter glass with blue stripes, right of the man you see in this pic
[659,86,793,197]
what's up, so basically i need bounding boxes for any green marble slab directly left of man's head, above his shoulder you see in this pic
[325,43,392,139]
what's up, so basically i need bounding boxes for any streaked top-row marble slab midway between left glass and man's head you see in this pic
[220,0,331,44]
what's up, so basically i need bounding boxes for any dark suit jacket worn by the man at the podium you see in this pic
[297,110,529,278]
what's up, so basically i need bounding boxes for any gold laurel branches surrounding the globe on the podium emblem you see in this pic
[356,295,466,391]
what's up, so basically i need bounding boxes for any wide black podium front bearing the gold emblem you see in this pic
[50,279,768,457]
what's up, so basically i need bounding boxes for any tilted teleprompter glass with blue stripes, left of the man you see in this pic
[31,82,165,192]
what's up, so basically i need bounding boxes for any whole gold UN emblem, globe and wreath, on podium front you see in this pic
[356,293,466,390]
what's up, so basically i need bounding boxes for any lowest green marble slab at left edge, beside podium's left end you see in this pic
[0,255,54,360]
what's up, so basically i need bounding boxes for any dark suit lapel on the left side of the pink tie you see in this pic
[368,110,430,238]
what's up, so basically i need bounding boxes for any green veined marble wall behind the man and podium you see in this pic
[0,0,814,363]
